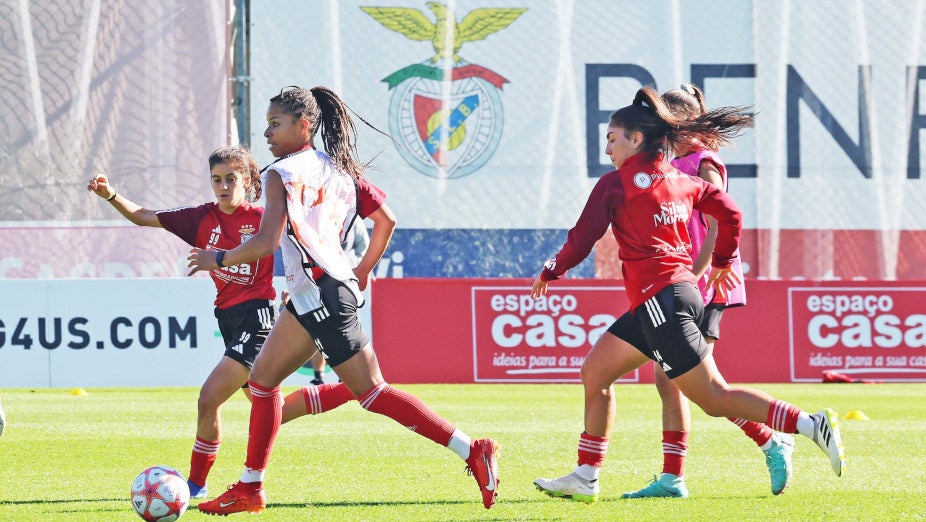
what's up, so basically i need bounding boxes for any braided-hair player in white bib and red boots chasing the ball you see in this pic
[189,87,499,515]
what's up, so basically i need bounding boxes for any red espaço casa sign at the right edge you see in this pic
[788,287,926,382]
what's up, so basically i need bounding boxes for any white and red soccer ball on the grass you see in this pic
[132,466,190,522]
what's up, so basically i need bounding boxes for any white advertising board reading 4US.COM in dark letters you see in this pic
[0,278,322,388]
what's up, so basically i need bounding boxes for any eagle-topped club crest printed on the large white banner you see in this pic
[360,2,527,179]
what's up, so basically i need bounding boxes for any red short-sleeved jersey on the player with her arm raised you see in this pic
[156,198,276,308]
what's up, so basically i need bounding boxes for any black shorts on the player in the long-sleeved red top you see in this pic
[608,283,708,379]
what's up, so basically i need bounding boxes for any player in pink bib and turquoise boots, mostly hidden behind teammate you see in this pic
[622,83,794,498]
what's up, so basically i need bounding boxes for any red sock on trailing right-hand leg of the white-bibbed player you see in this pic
[359,382,454,446]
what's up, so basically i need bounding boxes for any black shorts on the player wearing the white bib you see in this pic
[286,274,370,368]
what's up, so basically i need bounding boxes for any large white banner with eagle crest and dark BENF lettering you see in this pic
[251,0,926,230]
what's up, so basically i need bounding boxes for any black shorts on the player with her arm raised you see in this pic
[215,299,277,369]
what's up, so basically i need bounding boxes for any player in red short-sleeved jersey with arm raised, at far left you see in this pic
[87,147,354,498]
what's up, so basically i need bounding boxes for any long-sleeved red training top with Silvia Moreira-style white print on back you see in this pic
[540,154,742,310]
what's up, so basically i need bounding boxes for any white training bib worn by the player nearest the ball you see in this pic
[269,149,363,315]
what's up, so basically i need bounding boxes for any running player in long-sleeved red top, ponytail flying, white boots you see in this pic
[531,87,845,502]
